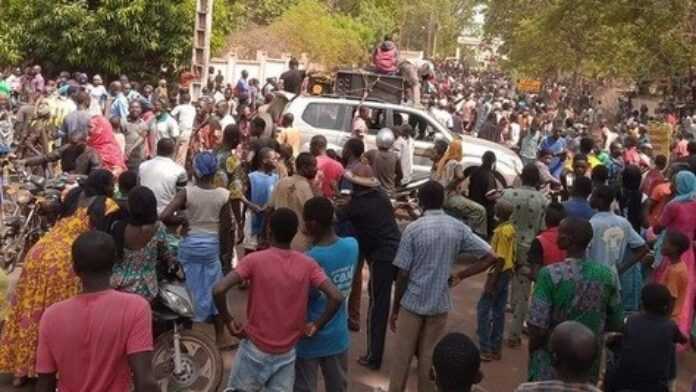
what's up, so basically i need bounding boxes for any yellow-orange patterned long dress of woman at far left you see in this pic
[0,199,118,377]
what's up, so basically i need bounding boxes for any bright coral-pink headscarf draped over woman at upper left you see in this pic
[87,116,126,177]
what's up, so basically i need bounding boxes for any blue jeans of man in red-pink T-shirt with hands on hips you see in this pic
[225,339,295,392]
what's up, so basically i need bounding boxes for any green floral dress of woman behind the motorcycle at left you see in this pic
[111,222,173,301]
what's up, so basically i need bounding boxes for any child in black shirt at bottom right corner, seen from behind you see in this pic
[606,283,687,392]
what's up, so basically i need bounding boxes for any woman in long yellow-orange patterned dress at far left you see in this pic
[0,170,118,386]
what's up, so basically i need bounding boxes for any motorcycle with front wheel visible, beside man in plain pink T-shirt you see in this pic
[152,269,224,391]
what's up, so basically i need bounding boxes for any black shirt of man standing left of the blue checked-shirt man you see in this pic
[339,189,401,263]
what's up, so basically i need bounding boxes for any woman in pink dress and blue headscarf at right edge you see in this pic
[654,170,696,344]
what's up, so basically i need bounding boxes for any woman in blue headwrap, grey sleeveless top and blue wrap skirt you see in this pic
[160,151,234,346]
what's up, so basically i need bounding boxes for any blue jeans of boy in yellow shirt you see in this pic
[476,271,510,353]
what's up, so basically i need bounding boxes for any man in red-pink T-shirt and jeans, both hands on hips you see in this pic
[213,208,343,392]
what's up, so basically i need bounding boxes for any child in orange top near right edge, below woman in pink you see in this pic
[659,231,690,323]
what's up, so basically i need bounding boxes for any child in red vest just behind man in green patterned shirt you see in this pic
[527,202,566,277]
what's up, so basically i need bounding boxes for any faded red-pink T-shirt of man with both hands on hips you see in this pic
[235,248,327,354]
